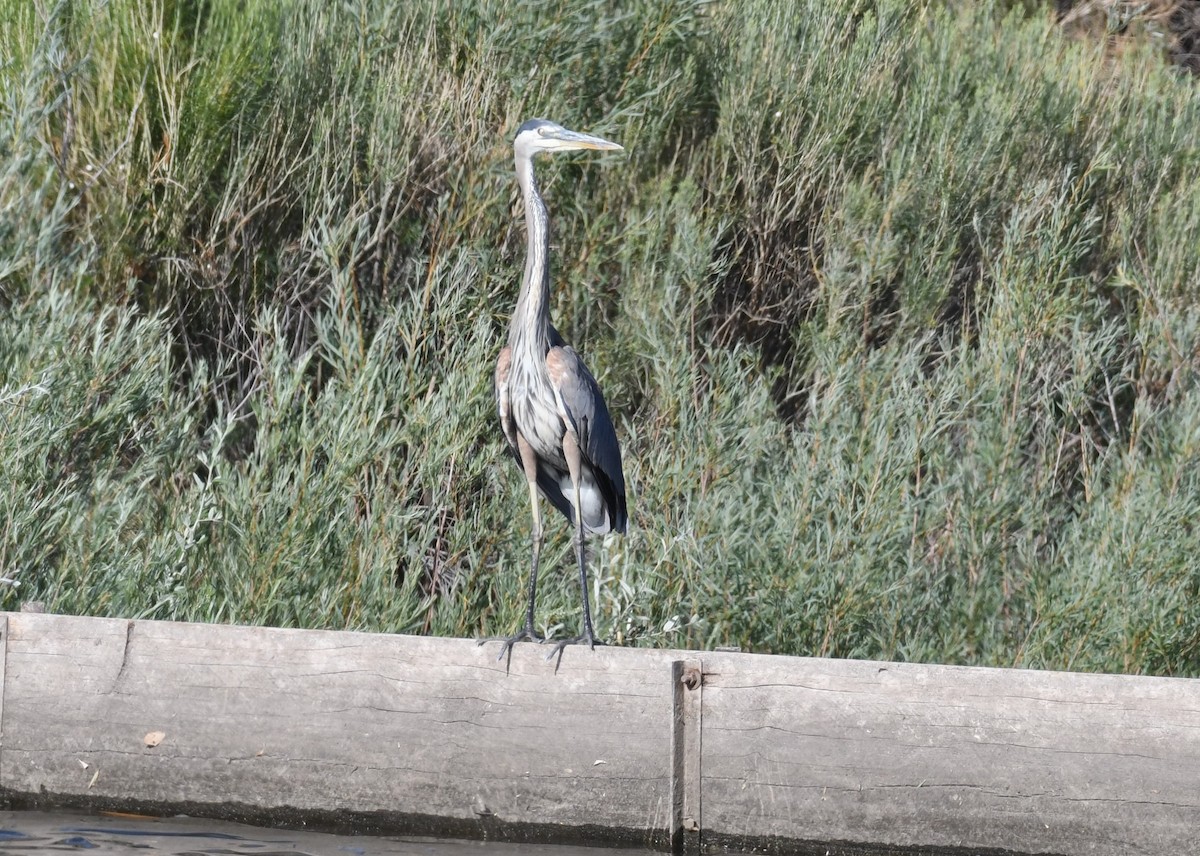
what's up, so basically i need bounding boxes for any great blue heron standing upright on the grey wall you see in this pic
[480,119,628,669]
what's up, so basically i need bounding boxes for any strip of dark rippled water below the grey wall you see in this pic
[0,812,650,856]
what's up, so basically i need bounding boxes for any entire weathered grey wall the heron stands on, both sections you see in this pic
[0,613,1200,856]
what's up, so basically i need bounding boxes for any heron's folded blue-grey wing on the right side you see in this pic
[546,346,628,532]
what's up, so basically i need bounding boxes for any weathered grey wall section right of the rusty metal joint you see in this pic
[703,656,1200,856]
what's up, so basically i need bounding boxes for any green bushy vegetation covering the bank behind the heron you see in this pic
[0,0,1200,675]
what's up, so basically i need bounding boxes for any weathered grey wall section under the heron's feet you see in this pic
[0,613,671,846]
